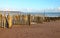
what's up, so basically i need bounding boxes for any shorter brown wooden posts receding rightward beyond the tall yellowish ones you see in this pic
[13,14,60,25]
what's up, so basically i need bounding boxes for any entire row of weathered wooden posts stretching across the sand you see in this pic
[0,14,60,28]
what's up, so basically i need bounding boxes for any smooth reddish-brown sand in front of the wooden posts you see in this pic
[0,21,60,38]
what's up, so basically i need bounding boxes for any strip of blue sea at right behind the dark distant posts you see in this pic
[30,12,60,17]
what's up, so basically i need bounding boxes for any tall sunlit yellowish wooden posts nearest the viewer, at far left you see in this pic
[0,14,12,28]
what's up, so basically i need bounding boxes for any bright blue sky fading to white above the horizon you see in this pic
[0,0,60,11]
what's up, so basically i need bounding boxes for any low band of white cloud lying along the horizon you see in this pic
[0,7,60,12]
